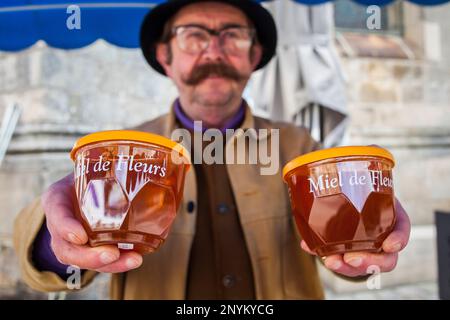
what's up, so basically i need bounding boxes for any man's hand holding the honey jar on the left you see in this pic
[41,175,142,273]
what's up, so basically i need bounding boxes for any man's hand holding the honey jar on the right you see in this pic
[301,199,411,277]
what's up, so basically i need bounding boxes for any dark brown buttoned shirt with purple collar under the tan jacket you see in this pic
[174,101,255,300]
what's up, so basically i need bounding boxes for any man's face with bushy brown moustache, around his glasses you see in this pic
[157,2,262,106]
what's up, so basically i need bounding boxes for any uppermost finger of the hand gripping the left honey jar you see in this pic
[41,175,88,244]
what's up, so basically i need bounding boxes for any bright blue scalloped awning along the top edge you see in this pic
[0,0,450,51]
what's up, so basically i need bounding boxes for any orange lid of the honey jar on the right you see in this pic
[283,146,395,180]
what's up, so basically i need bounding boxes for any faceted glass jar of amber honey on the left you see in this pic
[73,134,189,254]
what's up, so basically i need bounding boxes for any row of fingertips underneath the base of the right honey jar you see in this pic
[324,252,398,277]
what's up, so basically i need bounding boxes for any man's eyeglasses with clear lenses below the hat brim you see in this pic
[172,25,255,55]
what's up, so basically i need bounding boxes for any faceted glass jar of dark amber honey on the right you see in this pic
[284,147,395,256]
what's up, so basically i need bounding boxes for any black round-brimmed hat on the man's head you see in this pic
[140,0,277,75]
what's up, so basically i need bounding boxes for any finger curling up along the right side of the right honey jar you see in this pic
[383,199,411,253]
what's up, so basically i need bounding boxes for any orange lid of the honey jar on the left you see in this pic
[70,130,190,163]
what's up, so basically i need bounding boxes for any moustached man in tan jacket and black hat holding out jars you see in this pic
[15,0,410,299]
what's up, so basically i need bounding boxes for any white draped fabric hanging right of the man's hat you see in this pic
[248,0,347,147]
